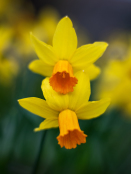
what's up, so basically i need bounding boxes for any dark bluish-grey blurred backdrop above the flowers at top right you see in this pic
[32,0,131,41]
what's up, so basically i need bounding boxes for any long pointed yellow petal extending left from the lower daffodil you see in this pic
[18,97,59,118]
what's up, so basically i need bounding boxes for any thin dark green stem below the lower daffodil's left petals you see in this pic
[32,130,47,174]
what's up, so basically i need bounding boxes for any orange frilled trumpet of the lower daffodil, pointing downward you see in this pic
[57,109,87,149]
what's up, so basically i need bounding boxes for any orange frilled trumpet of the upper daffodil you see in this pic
[50,60,78,94]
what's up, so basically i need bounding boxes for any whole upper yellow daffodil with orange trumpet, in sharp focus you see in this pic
[29,17,108,94]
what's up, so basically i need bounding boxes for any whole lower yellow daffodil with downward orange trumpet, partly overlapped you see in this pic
[19,71,110,149]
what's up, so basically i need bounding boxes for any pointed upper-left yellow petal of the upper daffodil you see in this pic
[30,33,58,66]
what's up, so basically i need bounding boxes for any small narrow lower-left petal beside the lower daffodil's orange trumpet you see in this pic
[34,119,59,132]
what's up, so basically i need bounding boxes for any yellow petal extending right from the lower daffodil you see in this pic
[76,98,110,120]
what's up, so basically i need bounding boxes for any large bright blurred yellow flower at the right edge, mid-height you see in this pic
[98,52,131,114]
